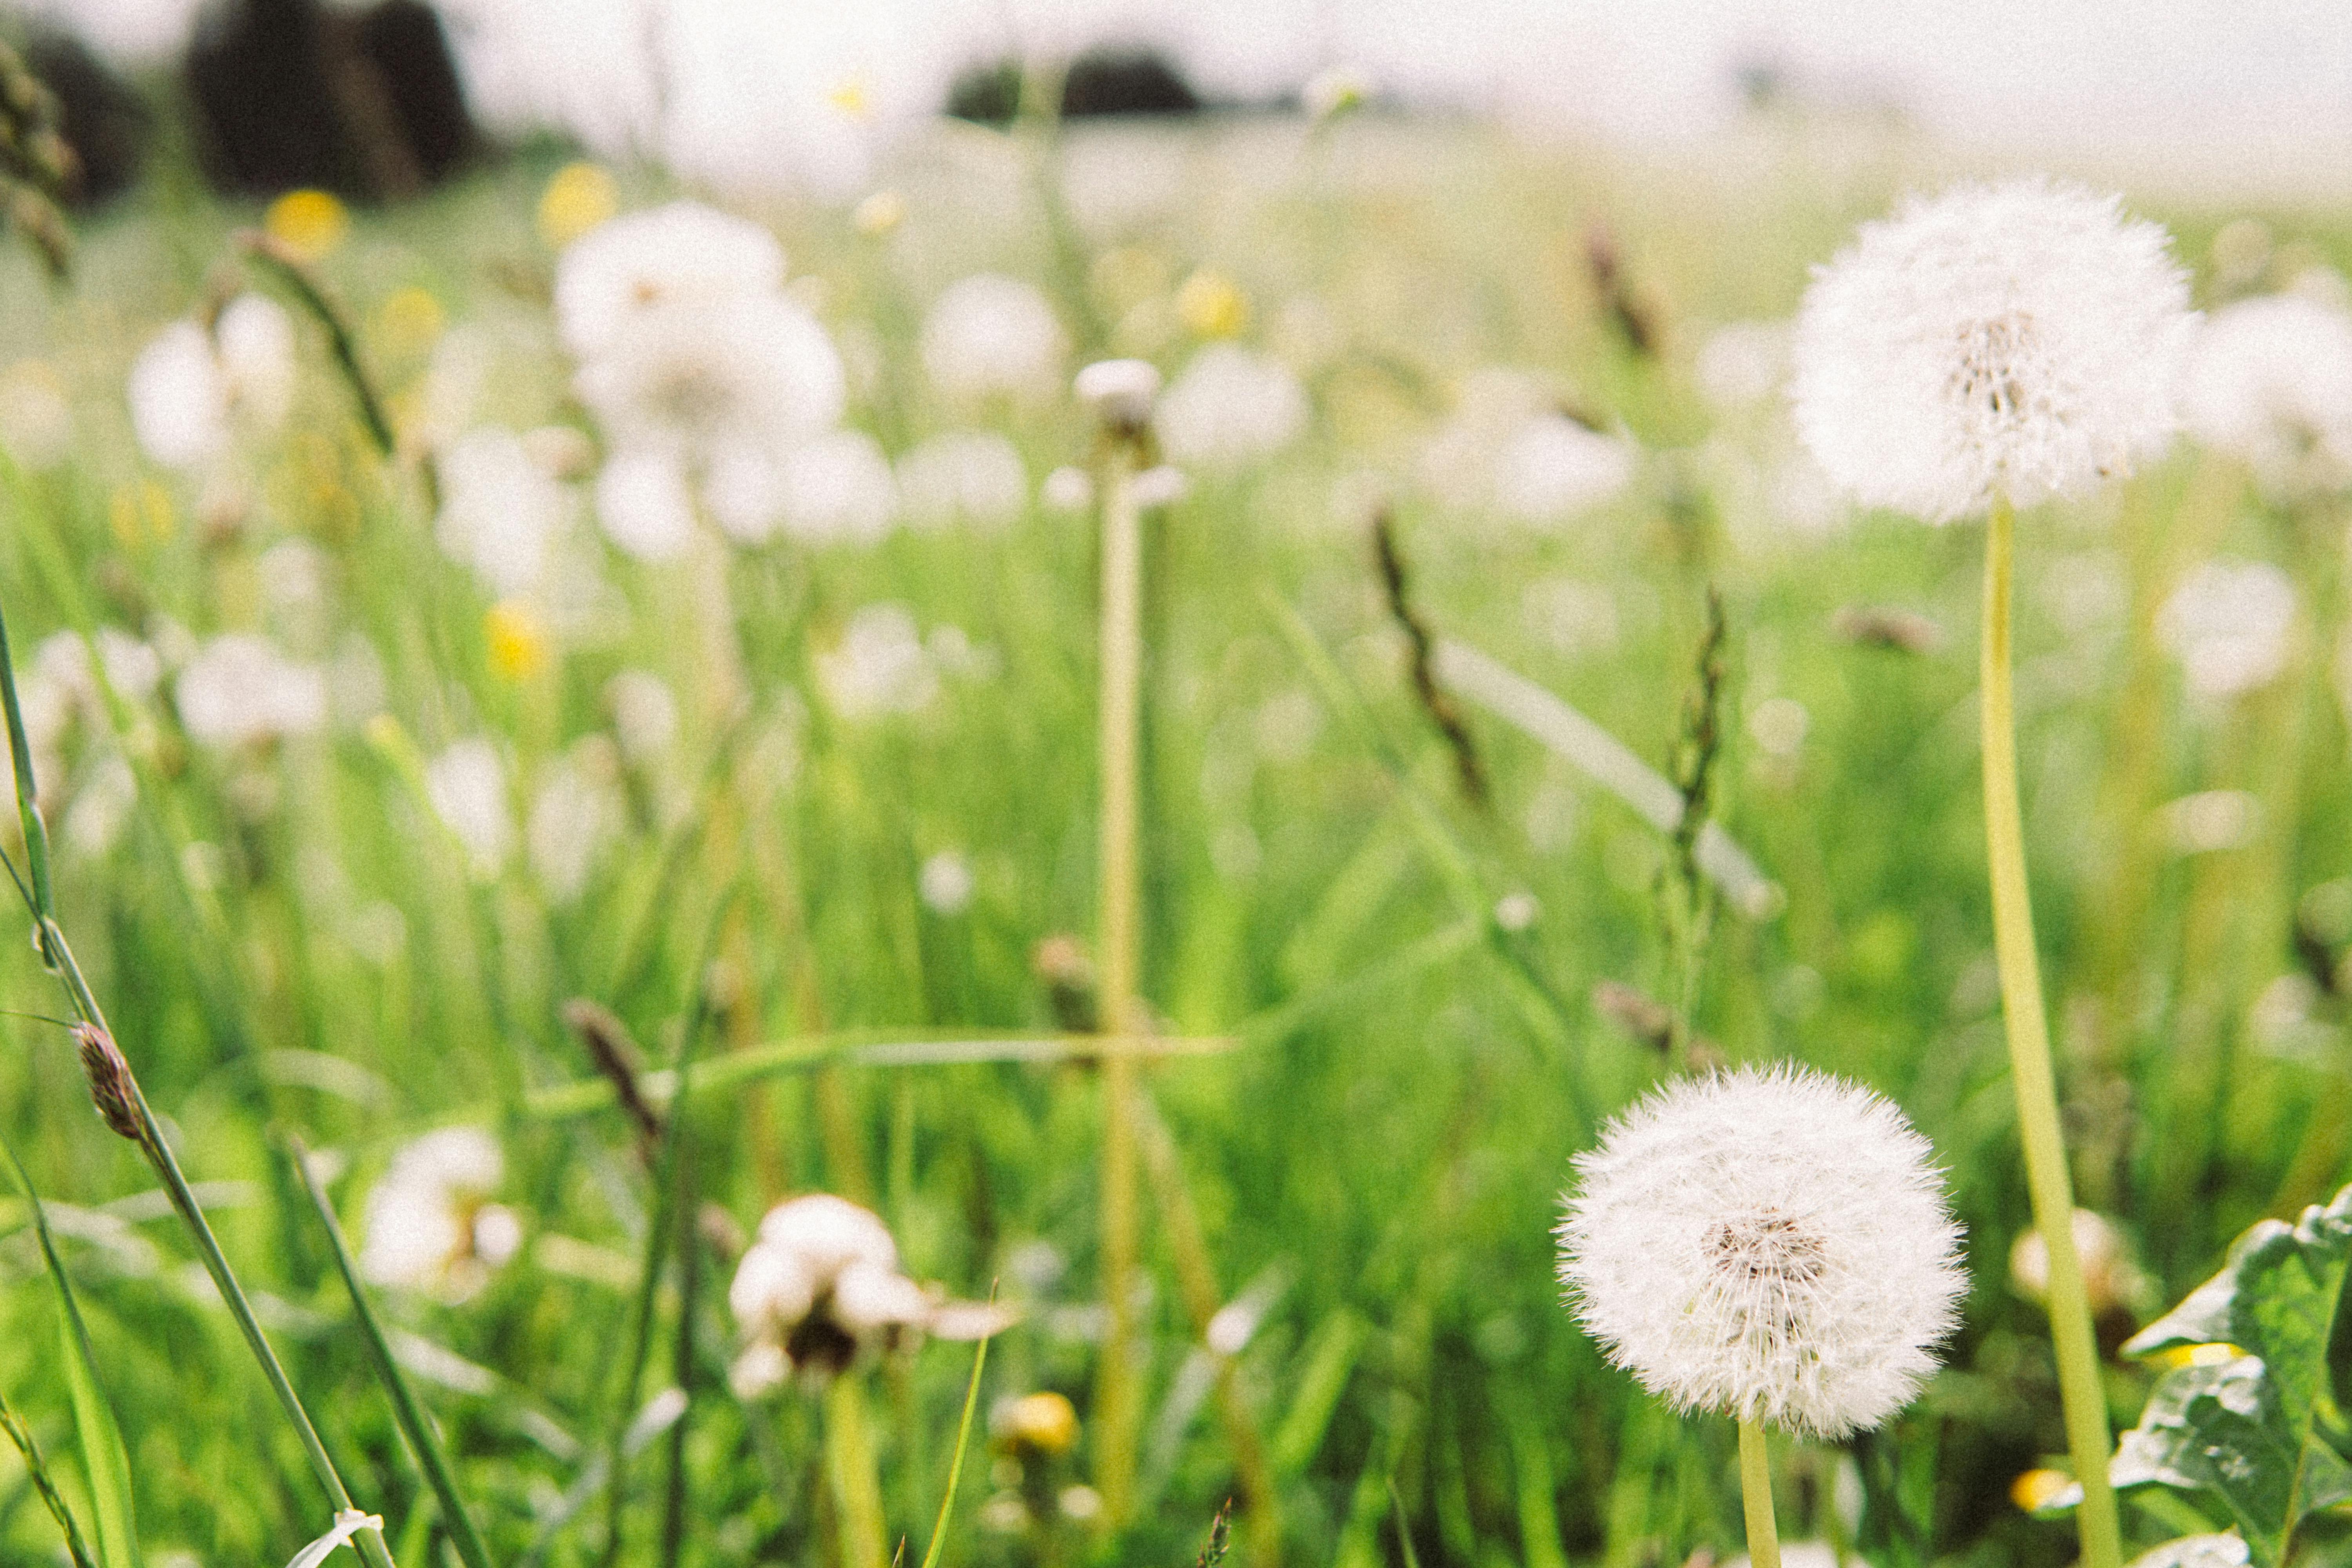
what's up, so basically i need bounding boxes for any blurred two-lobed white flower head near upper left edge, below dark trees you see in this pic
[129,294,294,468]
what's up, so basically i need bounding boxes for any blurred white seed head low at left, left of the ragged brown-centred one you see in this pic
[360,1126,522,1300]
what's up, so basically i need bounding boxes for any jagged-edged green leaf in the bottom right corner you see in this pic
[2107,1187,2352,1568]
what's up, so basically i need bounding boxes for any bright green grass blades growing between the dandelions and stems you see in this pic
[0,122,2352,1568]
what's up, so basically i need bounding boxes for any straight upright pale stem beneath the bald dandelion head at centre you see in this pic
[1096,439,1143,1528]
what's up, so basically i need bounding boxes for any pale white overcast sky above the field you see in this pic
[38,0,2352,190]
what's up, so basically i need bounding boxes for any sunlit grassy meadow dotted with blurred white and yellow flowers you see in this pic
[0,111,2352,1568]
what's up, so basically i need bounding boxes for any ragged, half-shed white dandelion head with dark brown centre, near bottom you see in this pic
[727,1192,1011,1399]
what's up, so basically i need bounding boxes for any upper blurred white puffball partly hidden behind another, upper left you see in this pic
[555,202,783,360]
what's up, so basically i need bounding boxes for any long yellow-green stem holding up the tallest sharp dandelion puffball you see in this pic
[1983,498,2122,1568]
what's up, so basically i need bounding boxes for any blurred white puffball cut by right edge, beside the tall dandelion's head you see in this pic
[2180,294,2352,489]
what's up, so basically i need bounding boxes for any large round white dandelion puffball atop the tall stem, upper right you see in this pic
[1790,181,2197,522]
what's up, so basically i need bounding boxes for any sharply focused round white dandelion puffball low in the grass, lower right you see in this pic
[1557,1063,1966,1439]
